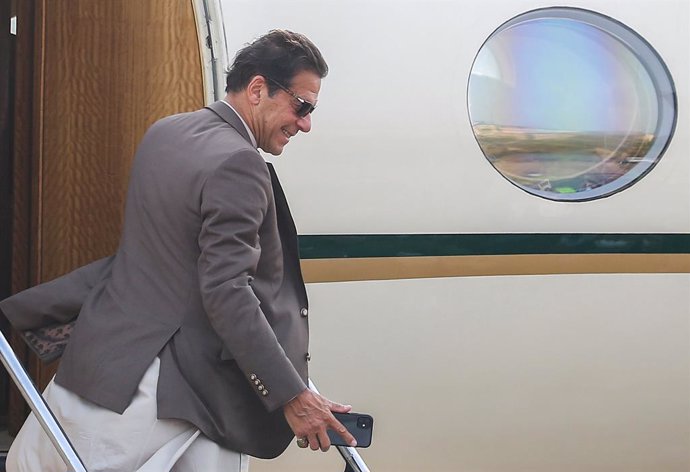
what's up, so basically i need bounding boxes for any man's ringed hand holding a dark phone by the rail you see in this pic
[283,389,357,452]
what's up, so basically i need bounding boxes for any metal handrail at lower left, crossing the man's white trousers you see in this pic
[0,333,87,472]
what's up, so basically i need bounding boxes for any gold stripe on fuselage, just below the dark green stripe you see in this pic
[302,254,690,283]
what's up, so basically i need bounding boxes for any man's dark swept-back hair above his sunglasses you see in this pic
[225,30,328,95]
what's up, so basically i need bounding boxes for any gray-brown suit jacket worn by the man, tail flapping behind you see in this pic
[0,102,308,458]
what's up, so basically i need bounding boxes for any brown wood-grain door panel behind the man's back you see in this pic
[11,0,204,434]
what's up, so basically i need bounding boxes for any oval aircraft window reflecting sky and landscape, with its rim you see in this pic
[468,8,676,201]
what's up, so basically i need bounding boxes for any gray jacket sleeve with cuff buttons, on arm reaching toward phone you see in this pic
[198,150,306,411]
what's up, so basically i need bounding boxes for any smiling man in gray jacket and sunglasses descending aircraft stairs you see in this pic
[0,30,354,472]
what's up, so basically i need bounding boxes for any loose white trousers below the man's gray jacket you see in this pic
[6,358,249,472]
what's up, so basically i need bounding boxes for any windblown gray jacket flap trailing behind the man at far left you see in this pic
[0,256,114,331]
